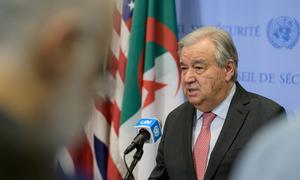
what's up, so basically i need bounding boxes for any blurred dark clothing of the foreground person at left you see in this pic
[0,110,57,180]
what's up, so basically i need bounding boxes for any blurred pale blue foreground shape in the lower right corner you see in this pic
[231,114,300,180]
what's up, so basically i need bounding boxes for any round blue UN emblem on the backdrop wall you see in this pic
[267,16,300,49]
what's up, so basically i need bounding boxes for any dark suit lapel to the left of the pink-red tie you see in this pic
[180,103,197,180]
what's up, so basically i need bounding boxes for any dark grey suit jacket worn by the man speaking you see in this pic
[149,83,285,180]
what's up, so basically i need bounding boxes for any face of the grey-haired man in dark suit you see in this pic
[180,38,232,111]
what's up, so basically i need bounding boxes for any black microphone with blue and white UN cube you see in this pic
[124,118,161,155]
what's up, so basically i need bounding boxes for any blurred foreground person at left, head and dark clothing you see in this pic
[0,0,112,180]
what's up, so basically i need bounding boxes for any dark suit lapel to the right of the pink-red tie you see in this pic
[204,83,250,180]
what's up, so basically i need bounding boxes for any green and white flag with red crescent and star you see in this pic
[119,0,183,180]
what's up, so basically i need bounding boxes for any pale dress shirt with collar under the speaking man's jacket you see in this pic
[192,84,236,166]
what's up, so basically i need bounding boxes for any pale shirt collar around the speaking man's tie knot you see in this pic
[196,84,236,120]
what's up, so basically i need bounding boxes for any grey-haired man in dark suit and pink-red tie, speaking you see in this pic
[149,27,285,180]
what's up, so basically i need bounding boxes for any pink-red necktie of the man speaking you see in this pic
[193,112,216,180]
